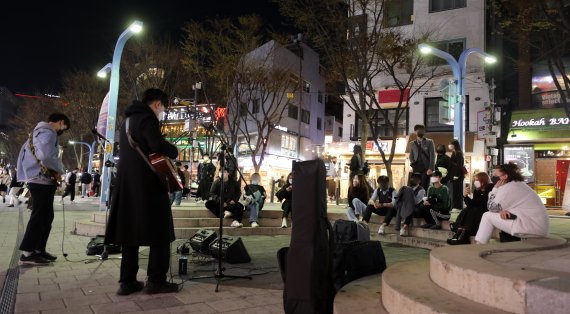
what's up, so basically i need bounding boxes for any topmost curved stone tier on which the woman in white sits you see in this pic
[430,237,570,313]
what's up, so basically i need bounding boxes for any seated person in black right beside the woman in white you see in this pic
[447,172,493,245]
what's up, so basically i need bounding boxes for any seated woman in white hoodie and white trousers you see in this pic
[475,163,549,244]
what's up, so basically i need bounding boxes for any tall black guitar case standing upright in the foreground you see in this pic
[280,160,335,314]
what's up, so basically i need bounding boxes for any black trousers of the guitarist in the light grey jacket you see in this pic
[20,183,57,252]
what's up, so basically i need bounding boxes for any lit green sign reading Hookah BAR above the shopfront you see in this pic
[507,108,570,143]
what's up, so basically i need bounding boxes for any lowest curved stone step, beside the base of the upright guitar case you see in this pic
[334,274,388,314]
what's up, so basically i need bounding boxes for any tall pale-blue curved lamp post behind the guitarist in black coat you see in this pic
[99,21,143,210]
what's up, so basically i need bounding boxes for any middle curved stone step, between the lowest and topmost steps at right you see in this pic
[382,260,512,314]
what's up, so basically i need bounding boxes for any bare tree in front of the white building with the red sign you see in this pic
[278,0,433,178]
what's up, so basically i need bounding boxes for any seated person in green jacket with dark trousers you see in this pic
[419,171,451,229]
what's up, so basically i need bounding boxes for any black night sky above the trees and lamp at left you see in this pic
[0,0,291,92]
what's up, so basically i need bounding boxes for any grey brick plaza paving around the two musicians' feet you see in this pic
[0,198,570,314]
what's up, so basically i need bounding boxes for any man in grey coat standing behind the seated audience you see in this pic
[409,124,435,189]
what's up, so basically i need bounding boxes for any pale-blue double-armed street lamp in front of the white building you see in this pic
[419,43,497,149]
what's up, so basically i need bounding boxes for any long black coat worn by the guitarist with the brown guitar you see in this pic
[105,102,178,246]
